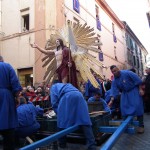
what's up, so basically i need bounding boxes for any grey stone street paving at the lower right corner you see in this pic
[68,114,150,150]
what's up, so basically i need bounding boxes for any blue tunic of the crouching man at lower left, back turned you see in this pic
[16,102,44,137]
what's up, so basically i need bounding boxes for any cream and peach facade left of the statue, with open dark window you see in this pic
[0,0,64,86]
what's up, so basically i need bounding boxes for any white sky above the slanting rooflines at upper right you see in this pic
[105,0,150,54]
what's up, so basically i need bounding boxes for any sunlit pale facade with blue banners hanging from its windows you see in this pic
[64,0,126,79]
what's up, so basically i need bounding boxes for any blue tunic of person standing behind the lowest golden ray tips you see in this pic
[85,79,102,98]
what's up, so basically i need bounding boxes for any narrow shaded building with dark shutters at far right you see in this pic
[123,21,148,77]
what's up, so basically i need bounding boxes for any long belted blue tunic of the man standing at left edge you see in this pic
[0,62,22,130]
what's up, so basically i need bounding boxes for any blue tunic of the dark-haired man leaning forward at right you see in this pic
[111,70,144,116]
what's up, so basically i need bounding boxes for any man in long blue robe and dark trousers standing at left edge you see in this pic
[0,56,22,150]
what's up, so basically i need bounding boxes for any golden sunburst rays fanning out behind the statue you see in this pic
[42,21,103,85]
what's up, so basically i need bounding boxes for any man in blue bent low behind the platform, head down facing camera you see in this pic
[88,93,111,112]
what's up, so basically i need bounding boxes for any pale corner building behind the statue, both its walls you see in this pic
[0,0,148,86]
